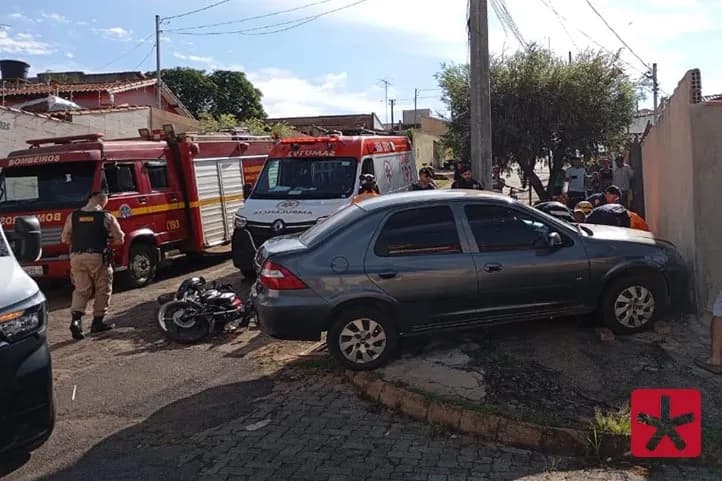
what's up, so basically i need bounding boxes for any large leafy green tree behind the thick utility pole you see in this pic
[437,46,635,198]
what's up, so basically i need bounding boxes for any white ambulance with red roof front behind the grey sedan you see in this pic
[232,135,418,277]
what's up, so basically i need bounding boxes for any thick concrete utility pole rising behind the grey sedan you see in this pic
[469,0,491,190]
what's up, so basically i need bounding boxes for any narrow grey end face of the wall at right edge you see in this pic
[690,102,722,312]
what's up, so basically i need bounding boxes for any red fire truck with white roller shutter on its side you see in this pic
[0,126,275,287]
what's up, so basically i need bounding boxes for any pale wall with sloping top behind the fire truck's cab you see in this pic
[0,107,96,157]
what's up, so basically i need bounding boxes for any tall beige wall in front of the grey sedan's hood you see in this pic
[642,70,722,315]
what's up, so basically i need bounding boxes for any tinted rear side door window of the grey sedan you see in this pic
[374,206,461,257]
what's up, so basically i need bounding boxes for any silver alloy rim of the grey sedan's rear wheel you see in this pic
[338,318,388,364]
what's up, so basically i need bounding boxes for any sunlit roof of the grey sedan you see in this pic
[358,189,515,212]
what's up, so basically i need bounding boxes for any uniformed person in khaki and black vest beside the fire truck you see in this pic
[61,192,125,340]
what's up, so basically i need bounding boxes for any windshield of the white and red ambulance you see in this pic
[251,157,358,199]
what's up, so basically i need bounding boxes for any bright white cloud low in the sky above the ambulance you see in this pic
[248,68,384,117]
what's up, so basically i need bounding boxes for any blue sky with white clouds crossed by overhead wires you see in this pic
[0,0,722,120]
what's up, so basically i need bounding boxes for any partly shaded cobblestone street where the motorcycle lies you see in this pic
[0,261,720,481]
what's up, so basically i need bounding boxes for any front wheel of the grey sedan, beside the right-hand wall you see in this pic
[601,275,665,334]
